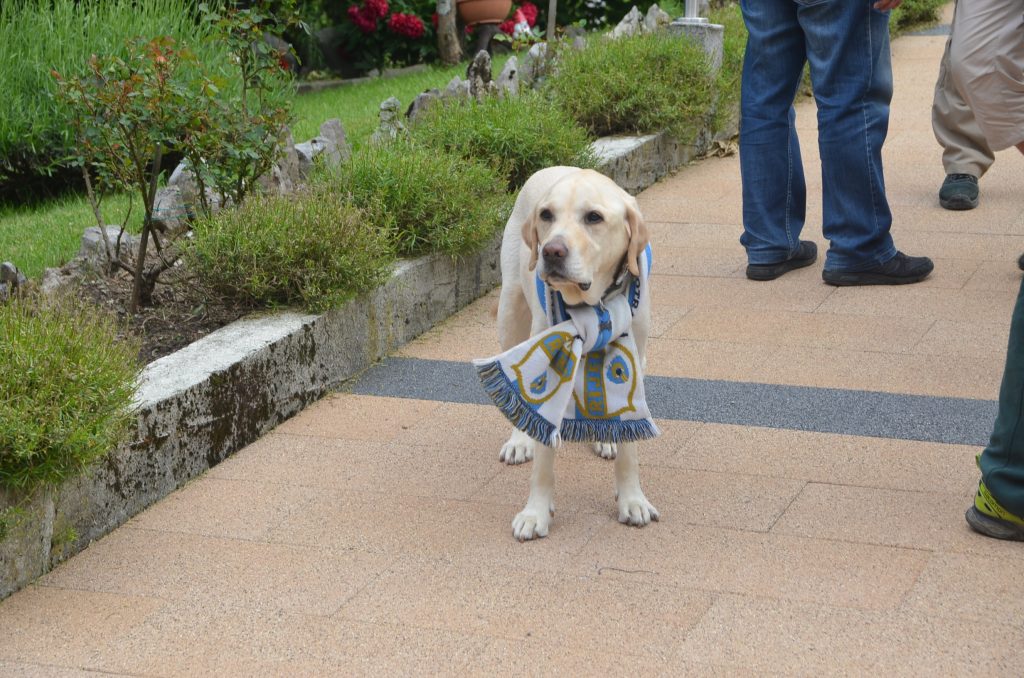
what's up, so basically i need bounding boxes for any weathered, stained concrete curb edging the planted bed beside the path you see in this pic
[0,119,737,599]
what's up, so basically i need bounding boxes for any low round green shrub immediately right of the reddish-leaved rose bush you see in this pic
[184,187,394,311]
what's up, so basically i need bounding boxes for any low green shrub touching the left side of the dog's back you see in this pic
[314,141,510,256]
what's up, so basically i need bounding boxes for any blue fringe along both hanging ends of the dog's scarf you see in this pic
[473,359,662,448]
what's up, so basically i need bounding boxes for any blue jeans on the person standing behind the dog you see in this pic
[739,0,896,271]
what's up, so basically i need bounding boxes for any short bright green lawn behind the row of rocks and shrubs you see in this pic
[0,56,507,278]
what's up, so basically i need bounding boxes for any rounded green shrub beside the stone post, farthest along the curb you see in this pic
[548,33,714,139]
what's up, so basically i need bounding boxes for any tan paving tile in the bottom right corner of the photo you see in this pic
[682,595,1024,677]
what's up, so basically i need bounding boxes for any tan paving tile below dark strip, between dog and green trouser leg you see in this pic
[668,424,978,495]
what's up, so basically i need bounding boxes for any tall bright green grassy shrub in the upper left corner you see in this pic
[0,0,225,195]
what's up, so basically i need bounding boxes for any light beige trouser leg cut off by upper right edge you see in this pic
[949,0,1024,151]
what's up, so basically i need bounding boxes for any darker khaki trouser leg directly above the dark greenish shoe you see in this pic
[932,0,995,177]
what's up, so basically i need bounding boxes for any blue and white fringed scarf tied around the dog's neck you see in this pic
[473,245,660,448]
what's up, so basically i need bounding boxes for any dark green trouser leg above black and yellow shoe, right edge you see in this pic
[980,274,1024,517]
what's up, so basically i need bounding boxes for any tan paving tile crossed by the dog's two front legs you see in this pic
[474,459,804,532]
